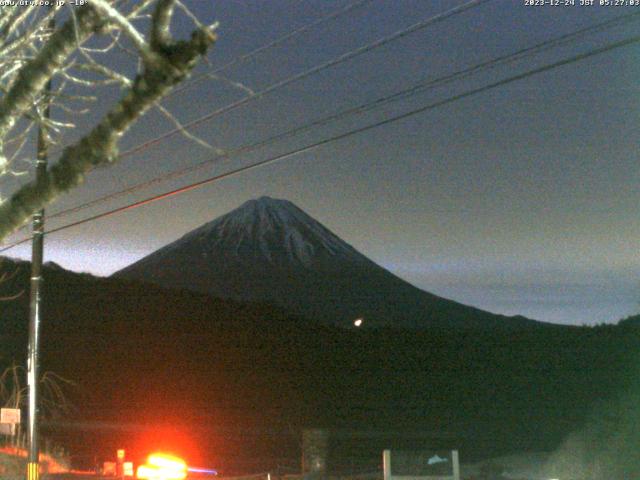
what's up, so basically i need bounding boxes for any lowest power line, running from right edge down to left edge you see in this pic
[0,31,640,253]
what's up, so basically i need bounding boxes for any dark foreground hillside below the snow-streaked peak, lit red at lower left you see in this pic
[0,261,640,471]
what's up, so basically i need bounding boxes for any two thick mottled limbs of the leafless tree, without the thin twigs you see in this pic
[0,6,215,238]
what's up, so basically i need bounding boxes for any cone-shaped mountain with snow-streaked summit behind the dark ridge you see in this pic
[114,197,541,328]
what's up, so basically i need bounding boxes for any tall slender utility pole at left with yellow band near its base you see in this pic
[27,12,55,480]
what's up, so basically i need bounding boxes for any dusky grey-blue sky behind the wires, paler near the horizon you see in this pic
[0,0,640,325]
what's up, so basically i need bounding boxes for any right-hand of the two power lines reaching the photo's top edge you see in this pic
[119,0,492,158]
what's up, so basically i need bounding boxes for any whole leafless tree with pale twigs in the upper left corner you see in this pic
[0,0,215,239]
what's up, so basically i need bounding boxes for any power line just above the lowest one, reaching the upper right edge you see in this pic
[36,12,640,227]
